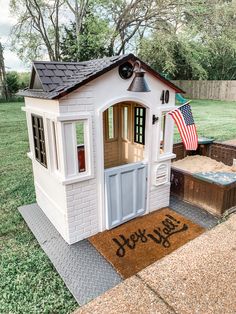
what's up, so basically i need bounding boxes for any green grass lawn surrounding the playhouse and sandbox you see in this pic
[0,100,236,313]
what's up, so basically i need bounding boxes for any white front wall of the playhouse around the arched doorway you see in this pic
[56,69,175,243]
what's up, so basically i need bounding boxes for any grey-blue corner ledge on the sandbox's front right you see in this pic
[193,171,236,186]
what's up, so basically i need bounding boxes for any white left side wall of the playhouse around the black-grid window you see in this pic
[24,97,69,241]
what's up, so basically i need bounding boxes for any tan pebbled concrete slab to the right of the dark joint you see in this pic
[139,215,236,314]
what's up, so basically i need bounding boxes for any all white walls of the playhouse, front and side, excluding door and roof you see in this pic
[25,62,175,244]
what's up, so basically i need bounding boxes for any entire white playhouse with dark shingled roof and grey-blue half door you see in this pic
[22,54,183,244]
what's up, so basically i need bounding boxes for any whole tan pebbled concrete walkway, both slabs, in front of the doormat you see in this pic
[75,214,236,314]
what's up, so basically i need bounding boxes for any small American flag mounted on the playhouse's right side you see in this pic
[168,102,198,150]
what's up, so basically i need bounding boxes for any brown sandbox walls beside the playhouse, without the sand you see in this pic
[171,143,236,216]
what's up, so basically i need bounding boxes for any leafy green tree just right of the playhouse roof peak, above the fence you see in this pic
[139,31,207,80]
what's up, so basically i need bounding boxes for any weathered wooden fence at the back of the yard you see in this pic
[173,80,236,101]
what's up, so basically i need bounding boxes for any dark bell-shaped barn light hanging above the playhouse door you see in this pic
[127,60,150,93]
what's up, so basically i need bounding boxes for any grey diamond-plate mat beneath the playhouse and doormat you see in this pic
[19,197,217,305]
